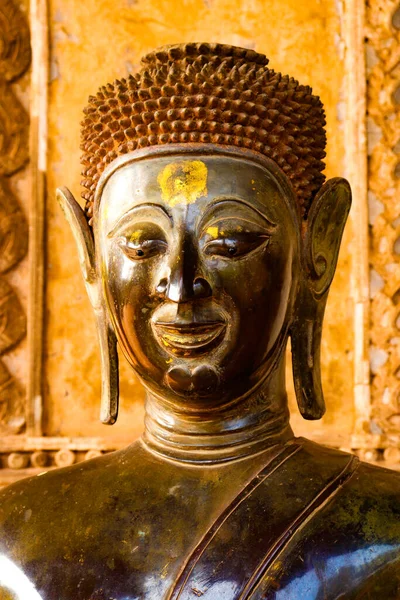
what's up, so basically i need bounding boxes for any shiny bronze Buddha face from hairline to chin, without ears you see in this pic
[95,153,298,410]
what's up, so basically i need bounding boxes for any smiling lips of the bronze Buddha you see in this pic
[153,321,226,357]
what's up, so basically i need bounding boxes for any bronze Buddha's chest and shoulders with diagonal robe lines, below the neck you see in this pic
[0,440,400,600]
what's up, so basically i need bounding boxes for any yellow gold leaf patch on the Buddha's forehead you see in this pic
[157,160,208,206]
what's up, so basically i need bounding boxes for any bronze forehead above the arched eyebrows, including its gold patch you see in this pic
[97,153,293,231]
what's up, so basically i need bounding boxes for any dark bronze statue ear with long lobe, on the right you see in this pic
[291,177,351,419]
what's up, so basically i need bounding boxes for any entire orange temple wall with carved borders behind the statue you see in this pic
[0,0,400,483]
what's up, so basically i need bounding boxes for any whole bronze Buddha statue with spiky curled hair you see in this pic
[0,43,400,600]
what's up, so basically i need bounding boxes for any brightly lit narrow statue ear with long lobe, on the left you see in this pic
[56,187,119,425]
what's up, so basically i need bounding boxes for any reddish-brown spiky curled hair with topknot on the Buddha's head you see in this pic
[81,43,326,224]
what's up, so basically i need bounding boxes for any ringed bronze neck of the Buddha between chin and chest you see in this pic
[143,357,293,464]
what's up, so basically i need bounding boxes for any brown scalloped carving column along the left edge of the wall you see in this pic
[0,0,31,435]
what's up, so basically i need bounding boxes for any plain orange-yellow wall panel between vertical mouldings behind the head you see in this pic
[43,0,354,443]
